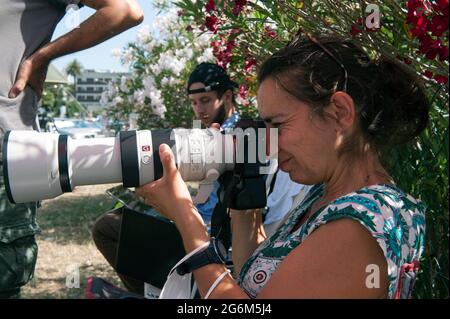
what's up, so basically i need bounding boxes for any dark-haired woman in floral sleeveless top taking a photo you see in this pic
[138,37,429,298]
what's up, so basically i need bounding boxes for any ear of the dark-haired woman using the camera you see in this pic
[325,91,356,131]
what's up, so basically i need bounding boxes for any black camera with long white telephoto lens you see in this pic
[3,119,272,209]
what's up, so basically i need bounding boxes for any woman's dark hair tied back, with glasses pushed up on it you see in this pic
[258,37,430,157]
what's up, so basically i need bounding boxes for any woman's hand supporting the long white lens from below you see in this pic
[136,144,194,221]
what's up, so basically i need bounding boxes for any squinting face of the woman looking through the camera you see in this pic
[258,78,337,185]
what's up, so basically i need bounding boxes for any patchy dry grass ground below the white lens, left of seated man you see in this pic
[22,185,123,299]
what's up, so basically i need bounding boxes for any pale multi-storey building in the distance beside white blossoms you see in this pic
[75,69,130,113]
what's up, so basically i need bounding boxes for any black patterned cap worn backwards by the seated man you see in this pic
[187,63,239,94]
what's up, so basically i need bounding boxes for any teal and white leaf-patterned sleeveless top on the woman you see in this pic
[239,184,426,298]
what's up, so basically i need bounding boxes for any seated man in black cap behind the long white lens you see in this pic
[92,63,239,295]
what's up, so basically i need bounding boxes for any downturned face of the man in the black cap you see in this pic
[189,82,225,127]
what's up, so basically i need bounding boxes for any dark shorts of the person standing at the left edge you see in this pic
[0,236,38,299]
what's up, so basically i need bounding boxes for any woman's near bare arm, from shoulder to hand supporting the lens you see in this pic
[136,144,388,299]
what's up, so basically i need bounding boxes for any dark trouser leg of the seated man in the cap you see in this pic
[92,209,144,295]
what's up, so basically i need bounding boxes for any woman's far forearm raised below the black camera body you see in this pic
[230,209,267,276]
